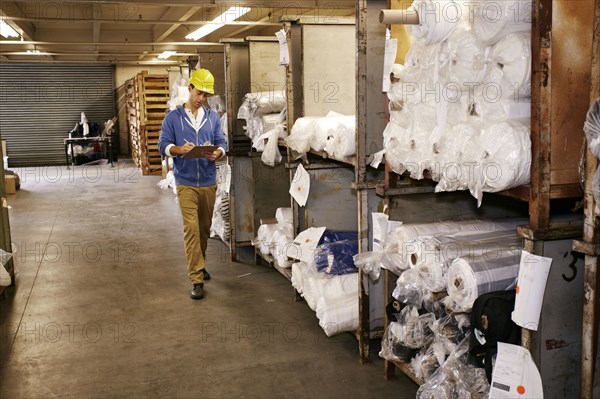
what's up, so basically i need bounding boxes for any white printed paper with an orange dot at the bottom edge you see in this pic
[489,342,544,399]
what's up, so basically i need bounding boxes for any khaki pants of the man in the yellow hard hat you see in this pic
[177,185,217,284]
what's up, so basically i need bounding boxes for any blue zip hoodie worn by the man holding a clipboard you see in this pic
[158,106,227,187]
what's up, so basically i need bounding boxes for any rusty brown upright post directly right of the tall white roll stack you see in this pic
[529,0,552,230]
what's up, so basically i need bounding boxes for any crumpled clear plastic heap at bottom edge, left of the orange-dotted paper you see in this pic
[417,336,490,399]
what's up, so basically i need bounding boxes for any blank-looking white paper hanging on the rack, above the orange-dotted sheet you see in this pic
[511,251,552,331]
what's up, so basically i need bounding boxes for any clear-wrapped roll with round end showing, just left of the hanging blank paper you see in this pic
[447,255,520,312]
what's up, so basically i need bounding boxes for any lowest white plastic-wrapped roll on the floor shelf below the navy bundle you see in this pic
[316,295,359,337]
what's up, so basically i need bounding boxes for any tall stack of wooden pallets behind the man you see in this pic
[125,71,170,175]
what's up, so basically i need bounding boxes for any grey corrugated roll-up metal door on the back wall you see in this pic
[0,64,118,167]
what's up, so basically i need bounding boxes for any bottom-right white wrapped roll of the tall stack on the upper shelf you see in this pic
[474,121,531,199]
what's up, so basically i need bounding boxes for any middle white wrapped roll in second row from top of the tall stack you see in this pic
[439,27,489,90]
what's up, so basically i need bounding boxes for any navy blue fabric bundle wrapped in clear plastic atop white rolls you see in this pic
[315,231,358,275]
